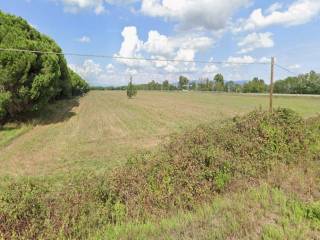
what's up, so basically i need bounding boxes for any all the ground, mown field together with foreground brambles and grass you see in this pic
[0,91,320,239]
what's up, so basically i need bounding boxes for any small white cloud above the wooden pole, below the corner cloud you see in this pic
[238,32,274,54]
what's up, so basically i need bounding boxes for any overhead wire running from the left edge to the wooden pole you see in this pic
[0,48,269,65]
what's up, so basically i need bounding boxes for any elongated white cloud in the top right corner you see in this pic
[237,0,320,31]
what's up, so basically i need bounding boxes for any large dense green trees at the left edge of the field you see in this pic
[0,11,89,126]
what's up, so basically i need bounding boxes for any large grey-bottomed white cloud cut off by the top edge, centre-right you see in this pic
[141,0,251,30]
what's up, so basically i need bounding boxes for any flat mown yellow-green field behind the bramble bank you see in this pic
[0,91,320,176]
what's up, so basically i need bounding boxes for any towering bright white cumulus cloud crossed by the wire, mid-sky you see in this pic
[115,26,214,72]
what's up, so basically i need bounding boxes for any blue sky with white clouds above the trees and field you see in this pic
[0,0,320,86]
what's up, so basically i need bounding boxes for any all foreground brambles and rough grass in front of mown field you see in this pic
[0,109,320,239]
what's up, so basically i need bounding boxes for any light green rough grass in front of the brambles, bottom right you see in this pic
[91,185,320,240]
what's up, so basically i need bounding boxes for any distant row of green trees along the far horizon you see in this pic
[102,71,320,94]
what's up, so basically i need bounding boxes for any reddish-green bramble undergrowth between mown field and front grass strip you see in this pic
[0,109,320,239]
